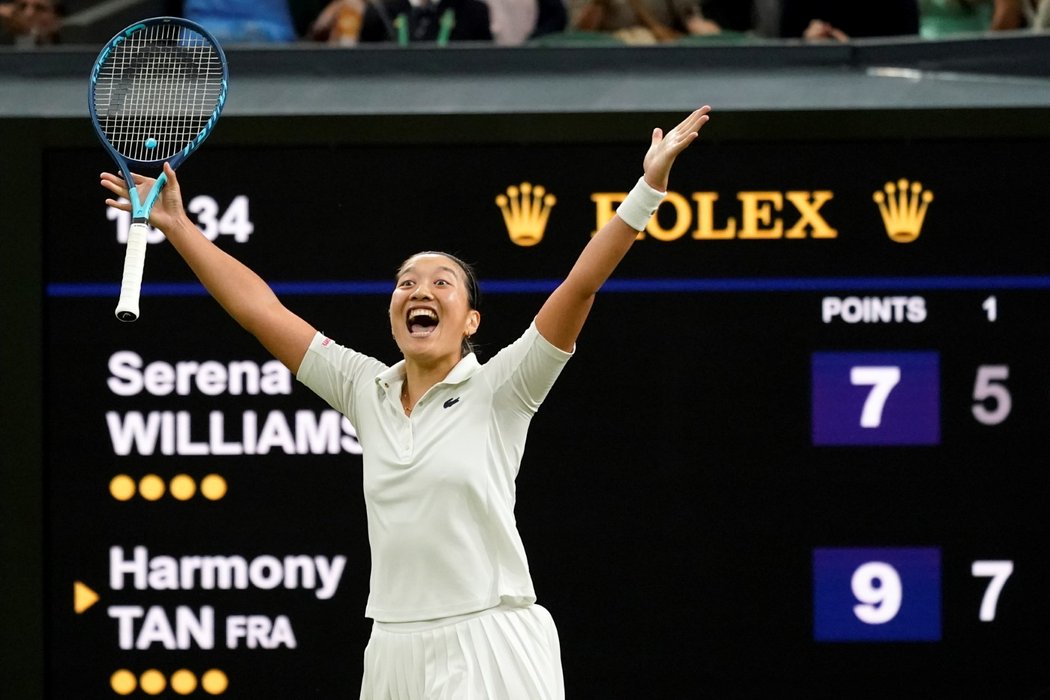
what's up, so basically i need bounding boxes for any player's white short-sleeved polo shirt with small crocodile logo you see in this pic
[297,322,571,622]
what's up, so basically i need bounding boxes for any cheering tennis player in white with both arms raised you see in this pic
[101,107,710,700]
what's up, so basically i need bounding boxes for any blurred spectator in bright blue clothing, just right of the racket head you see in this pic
[182,0,298,43]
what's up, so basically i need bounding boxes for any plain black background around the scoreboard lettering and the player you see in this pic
[6,35,1050,698]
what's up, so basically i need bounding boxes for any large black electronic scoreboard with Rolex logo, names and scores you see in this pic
[43,134,1050,698]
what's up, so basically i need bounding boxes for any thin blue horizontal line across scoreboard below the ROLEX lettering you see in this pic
[46,275,1050,298]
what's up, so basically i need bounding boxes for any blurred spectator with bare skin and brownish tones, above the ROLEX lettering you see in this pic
[572,0,721,44]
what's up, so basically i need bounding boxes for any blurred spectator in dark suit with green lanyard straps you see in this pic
[310,0,492,46]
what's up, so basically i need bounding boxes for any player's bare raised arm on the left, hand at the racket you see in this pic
[101,164,316,374]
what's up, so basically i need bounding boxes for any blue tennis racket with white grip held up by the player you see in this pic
[87,17,229,321]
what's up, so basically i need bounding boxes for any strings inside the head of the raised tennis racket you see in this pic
[95,24,224,162]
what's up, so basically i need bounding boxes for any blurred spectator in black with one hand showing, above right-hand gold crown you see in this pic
[780,0,919,41]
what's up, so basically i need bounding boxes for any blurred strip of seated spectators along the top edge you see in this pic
[0,0,1050,47]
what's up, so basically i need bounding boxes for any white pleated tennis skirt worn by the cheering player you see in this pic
[361,604,565,700]
